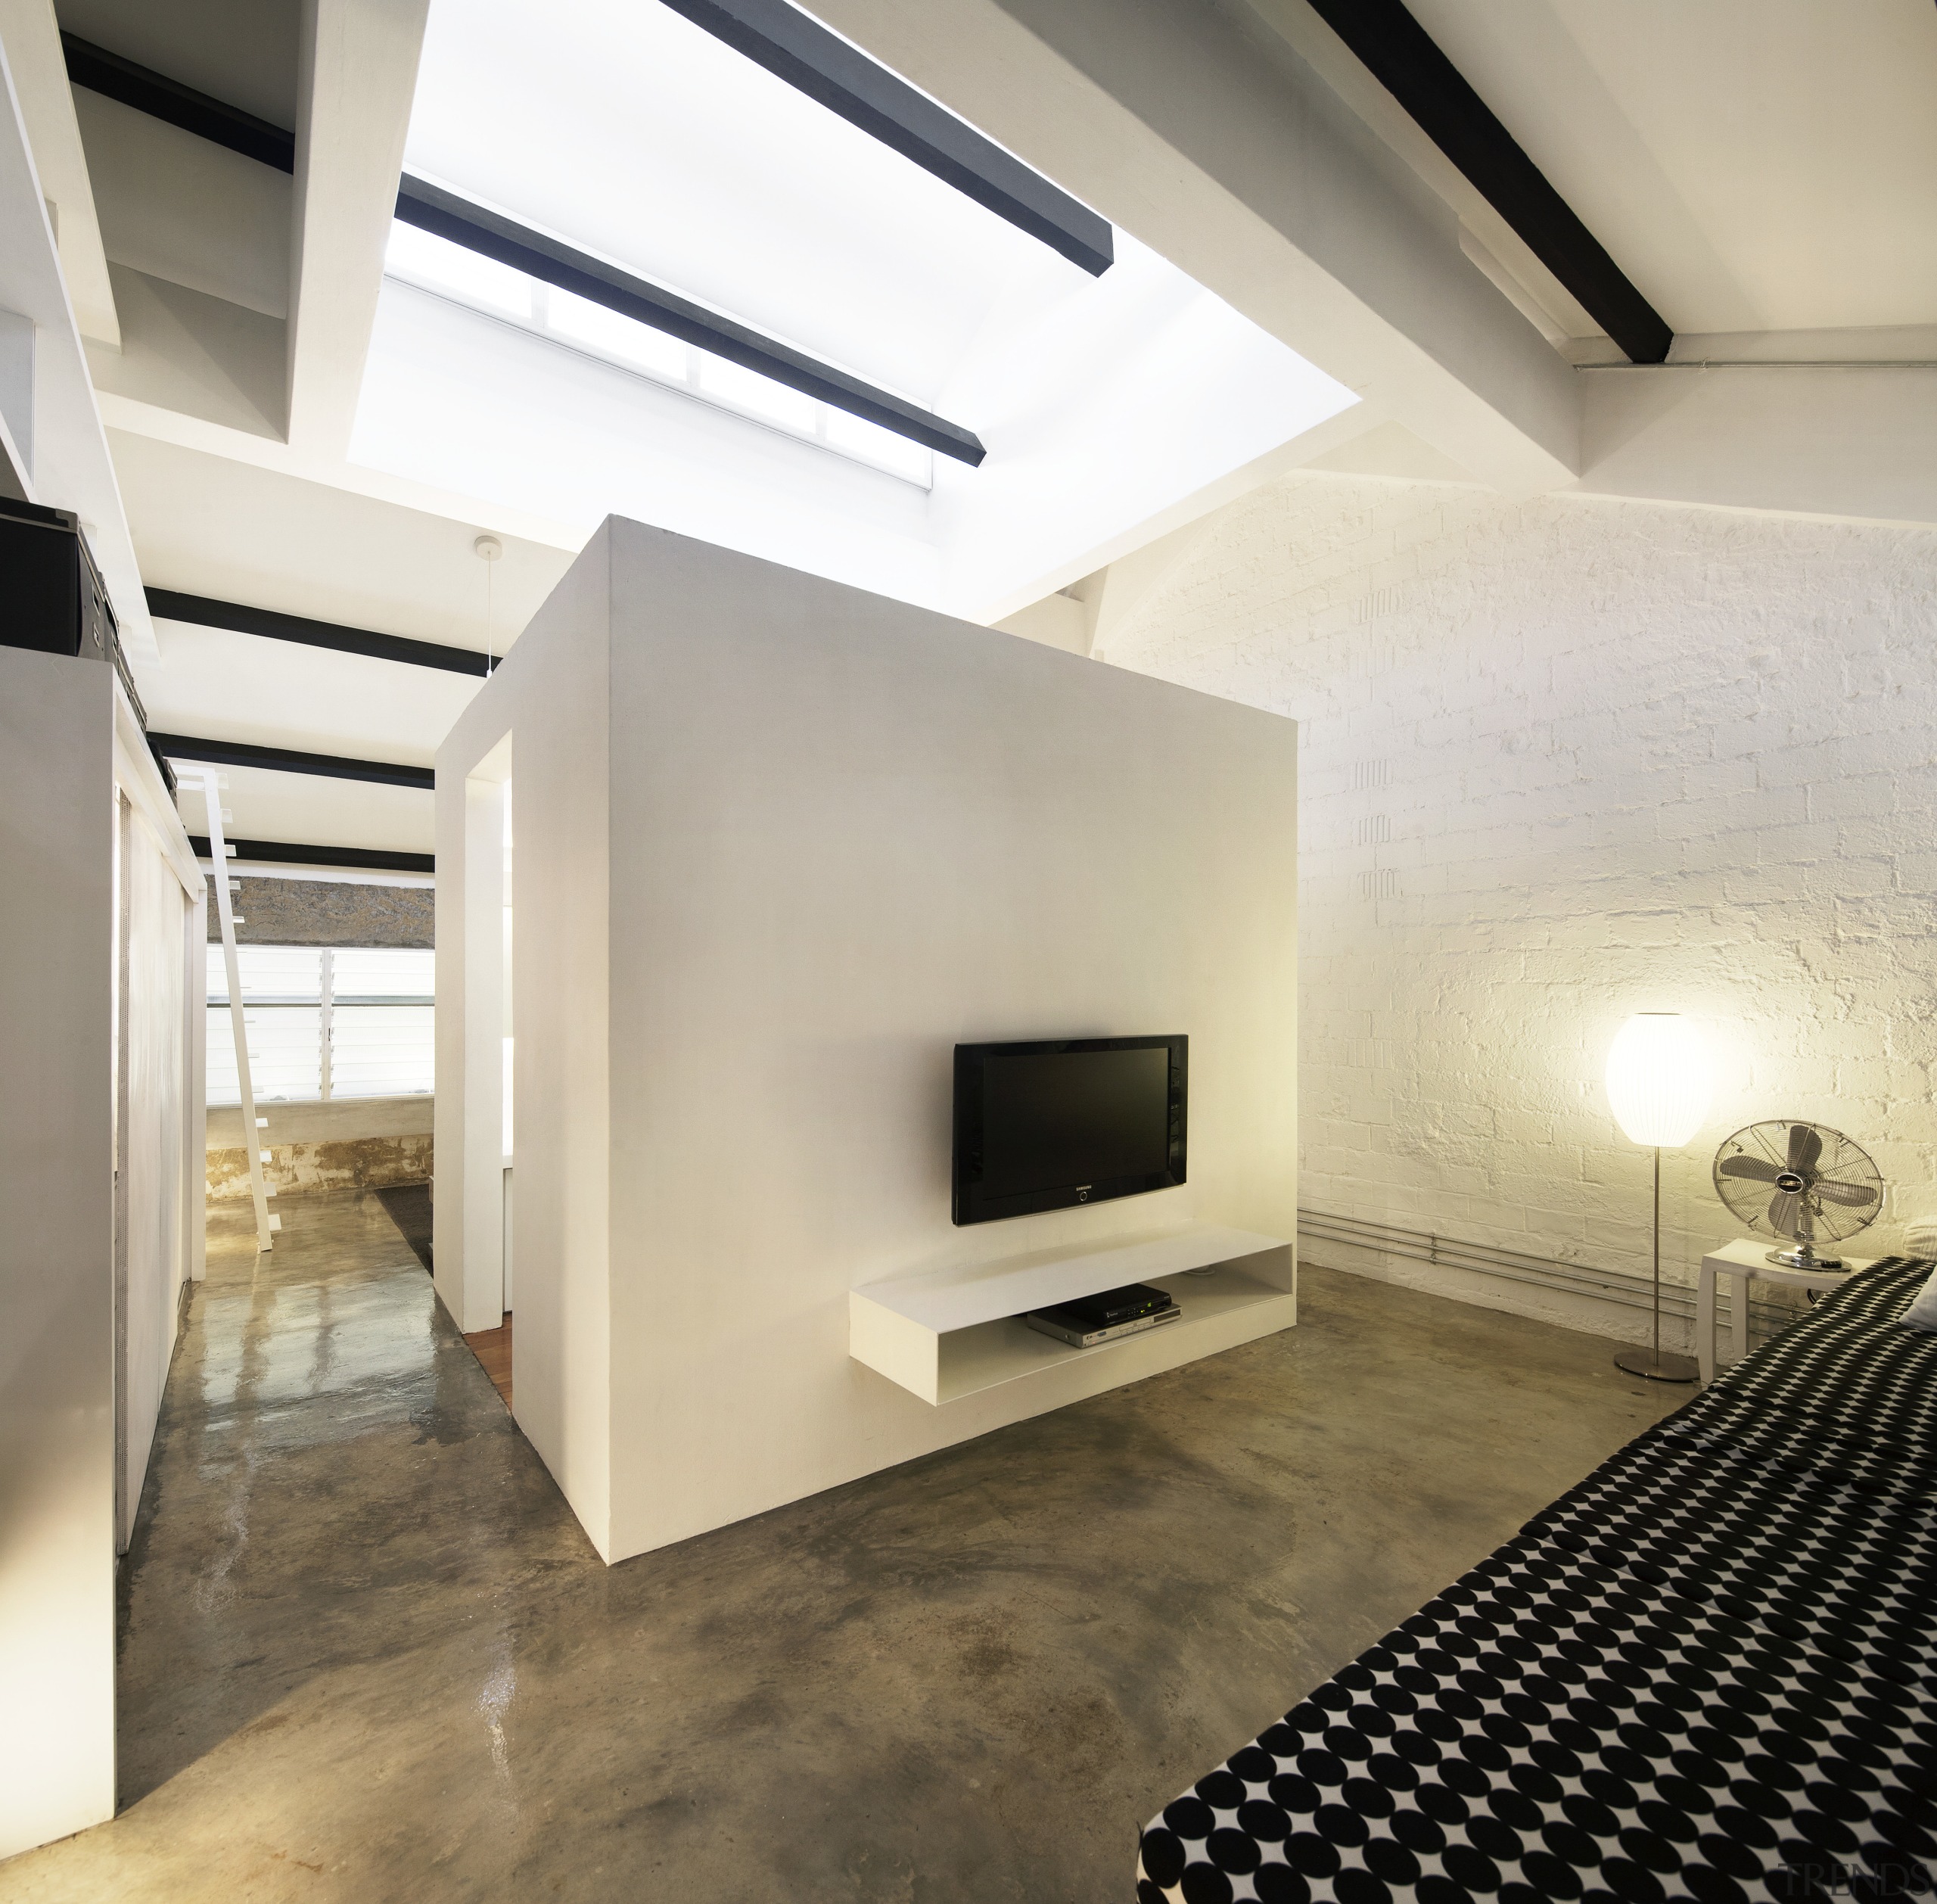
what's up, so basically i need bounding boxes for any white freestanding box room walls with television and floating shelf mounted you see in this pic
[436,519,1296,1559]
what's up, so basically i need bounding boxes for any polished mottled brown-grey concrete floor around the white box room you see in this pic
[0,1191,1681,1904]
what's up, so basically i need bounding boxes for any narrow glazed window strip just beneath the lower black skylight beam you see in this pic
[384,221,935,490]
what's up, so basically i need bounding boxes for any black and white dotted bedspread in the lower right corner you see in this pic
[1137,1259,1937,1904]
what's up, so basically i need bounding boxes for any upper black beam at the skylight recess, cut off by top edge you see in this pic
[664,0,1116,277]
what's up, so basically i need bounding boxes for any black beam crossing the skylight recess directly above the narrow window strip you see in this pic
[397,174,986,468]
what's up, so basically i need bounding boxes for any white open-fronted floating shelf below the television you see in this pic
[848,1224,1298,1406]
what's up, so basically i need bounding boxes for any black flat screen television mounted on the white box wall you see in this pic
[955,1036,1189,1224]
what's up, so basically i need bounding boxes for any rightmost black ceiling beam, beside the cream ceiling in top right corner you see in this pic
[1311,0,1675,364]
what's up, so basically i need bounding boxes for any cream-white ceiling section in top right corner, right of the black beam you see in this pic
[1408,0,1937,333]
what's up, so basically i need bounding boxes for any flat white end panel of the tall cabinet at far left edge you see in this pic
[0,647,117,1858]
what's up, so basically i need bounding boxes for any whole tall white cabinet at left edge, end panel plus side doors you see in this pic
[0,647,204,1858]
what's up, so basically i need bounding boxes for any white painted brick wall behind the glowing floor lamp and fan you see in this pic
[1106,474,1937,1335]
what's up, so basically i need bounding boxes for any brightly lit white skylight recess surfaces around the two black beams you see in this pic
[364,0,1354,620]
